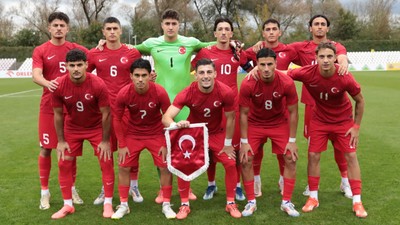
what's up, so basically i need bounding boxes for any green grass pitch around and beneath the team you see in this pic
[0,72,400,225]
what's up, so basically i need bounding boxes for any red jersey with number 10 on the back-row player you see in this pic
[192,45,247,99]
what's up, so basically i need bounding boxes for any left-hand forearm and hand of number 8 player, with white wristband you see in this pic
[239,106,253,162]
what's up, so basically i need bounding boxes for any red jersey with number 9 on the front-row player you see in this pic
[53,73,109,131]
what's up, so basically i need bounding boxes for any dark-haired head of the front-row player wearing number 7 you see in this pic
[130,58,151,93]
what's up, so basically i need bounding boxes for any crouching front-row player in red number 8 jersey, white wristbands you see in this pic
[240,48,299,217]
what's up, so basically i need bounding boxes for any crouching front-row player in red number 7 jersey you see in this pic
[111,59,176,219]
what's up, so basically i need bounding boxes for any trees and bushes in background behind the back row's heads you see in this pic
[0,0,400,50]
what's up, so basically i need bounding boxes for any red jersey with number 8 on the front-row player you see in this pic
[240,70,298,127]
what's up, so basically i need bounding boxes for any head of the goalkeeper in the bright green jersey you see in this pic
[161,9,179,40]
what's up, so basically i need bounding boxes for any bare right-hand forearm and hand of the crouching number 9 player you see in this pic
[97,106,112,161]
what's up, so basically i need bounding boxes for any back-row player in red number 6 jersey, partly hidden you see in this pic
[88,17,143,205]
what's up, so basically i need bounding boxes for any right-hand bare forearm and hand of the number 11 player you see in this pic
[346,92,365,148]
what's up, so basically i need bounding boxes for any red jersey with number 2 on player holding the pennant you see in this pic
[173,81,235,134]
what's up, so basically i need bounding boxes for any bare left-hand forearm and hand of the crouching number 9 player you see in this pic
[53,107,71,160]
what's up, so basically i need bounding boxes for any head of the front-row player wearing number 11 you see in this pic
[315,42,336,73]
